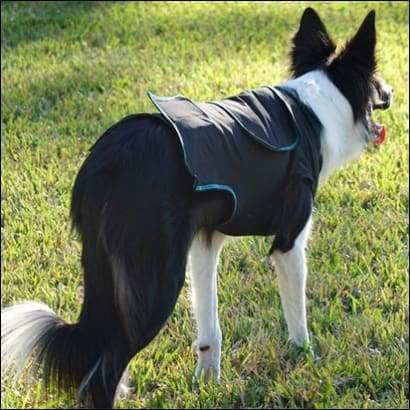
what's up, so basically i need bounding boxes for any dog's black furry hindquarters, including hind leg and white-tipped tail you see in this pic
[1,119,192,408]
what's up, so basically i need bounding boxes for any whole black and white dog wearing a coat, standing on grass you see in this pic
[1,8,392,407]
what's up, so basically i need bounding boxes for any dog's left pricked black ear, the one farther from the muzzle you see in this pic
[291,7,336,77]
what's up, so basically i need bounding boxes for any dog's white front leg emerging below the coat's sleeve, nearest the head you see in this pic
[273,217,311,346]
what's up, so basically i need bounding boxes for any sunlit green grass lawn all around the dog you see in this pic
[1,2,409,408]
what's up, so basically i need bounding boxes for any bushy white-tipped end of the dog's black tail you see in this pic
[1,302,120,405]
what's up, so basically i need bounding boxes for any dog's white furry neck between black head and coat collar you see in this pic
[284,70,366,185]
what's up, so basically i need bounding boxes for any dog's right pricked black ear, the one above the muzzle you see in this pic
[332,10,376,78]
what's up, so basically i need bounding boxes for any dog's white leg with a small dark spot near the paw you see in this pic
[190,232,225,382]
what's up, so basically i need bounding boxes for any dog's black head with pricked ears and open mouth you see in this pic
[291,8,393,144]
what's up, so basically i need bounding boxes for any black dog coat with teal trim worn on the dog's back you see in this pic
[148,86,322,252]
